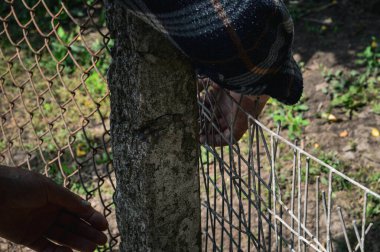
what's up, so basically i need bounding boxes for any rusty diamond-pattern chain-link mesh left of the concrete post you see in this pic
[0,0,118,251]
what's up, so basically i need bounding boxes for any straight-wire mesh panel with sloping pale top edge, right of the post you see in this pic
[198,82,380,251]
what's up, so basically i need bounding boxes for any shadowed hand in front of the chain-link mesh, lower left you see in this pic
[0,166,108,252]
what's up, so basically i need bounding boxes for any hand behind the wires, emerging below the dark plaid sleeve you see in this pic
[200,81,269,146]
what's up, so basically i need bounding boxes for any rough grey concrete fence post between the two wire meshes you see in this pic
[106,1,201,251]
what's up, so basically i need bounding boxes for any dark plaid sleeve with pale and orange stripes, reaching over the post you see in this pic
[121,0,303,104]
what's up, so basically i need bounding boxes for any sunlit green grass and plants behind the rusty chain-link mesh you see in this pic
[0,2,112,205]
